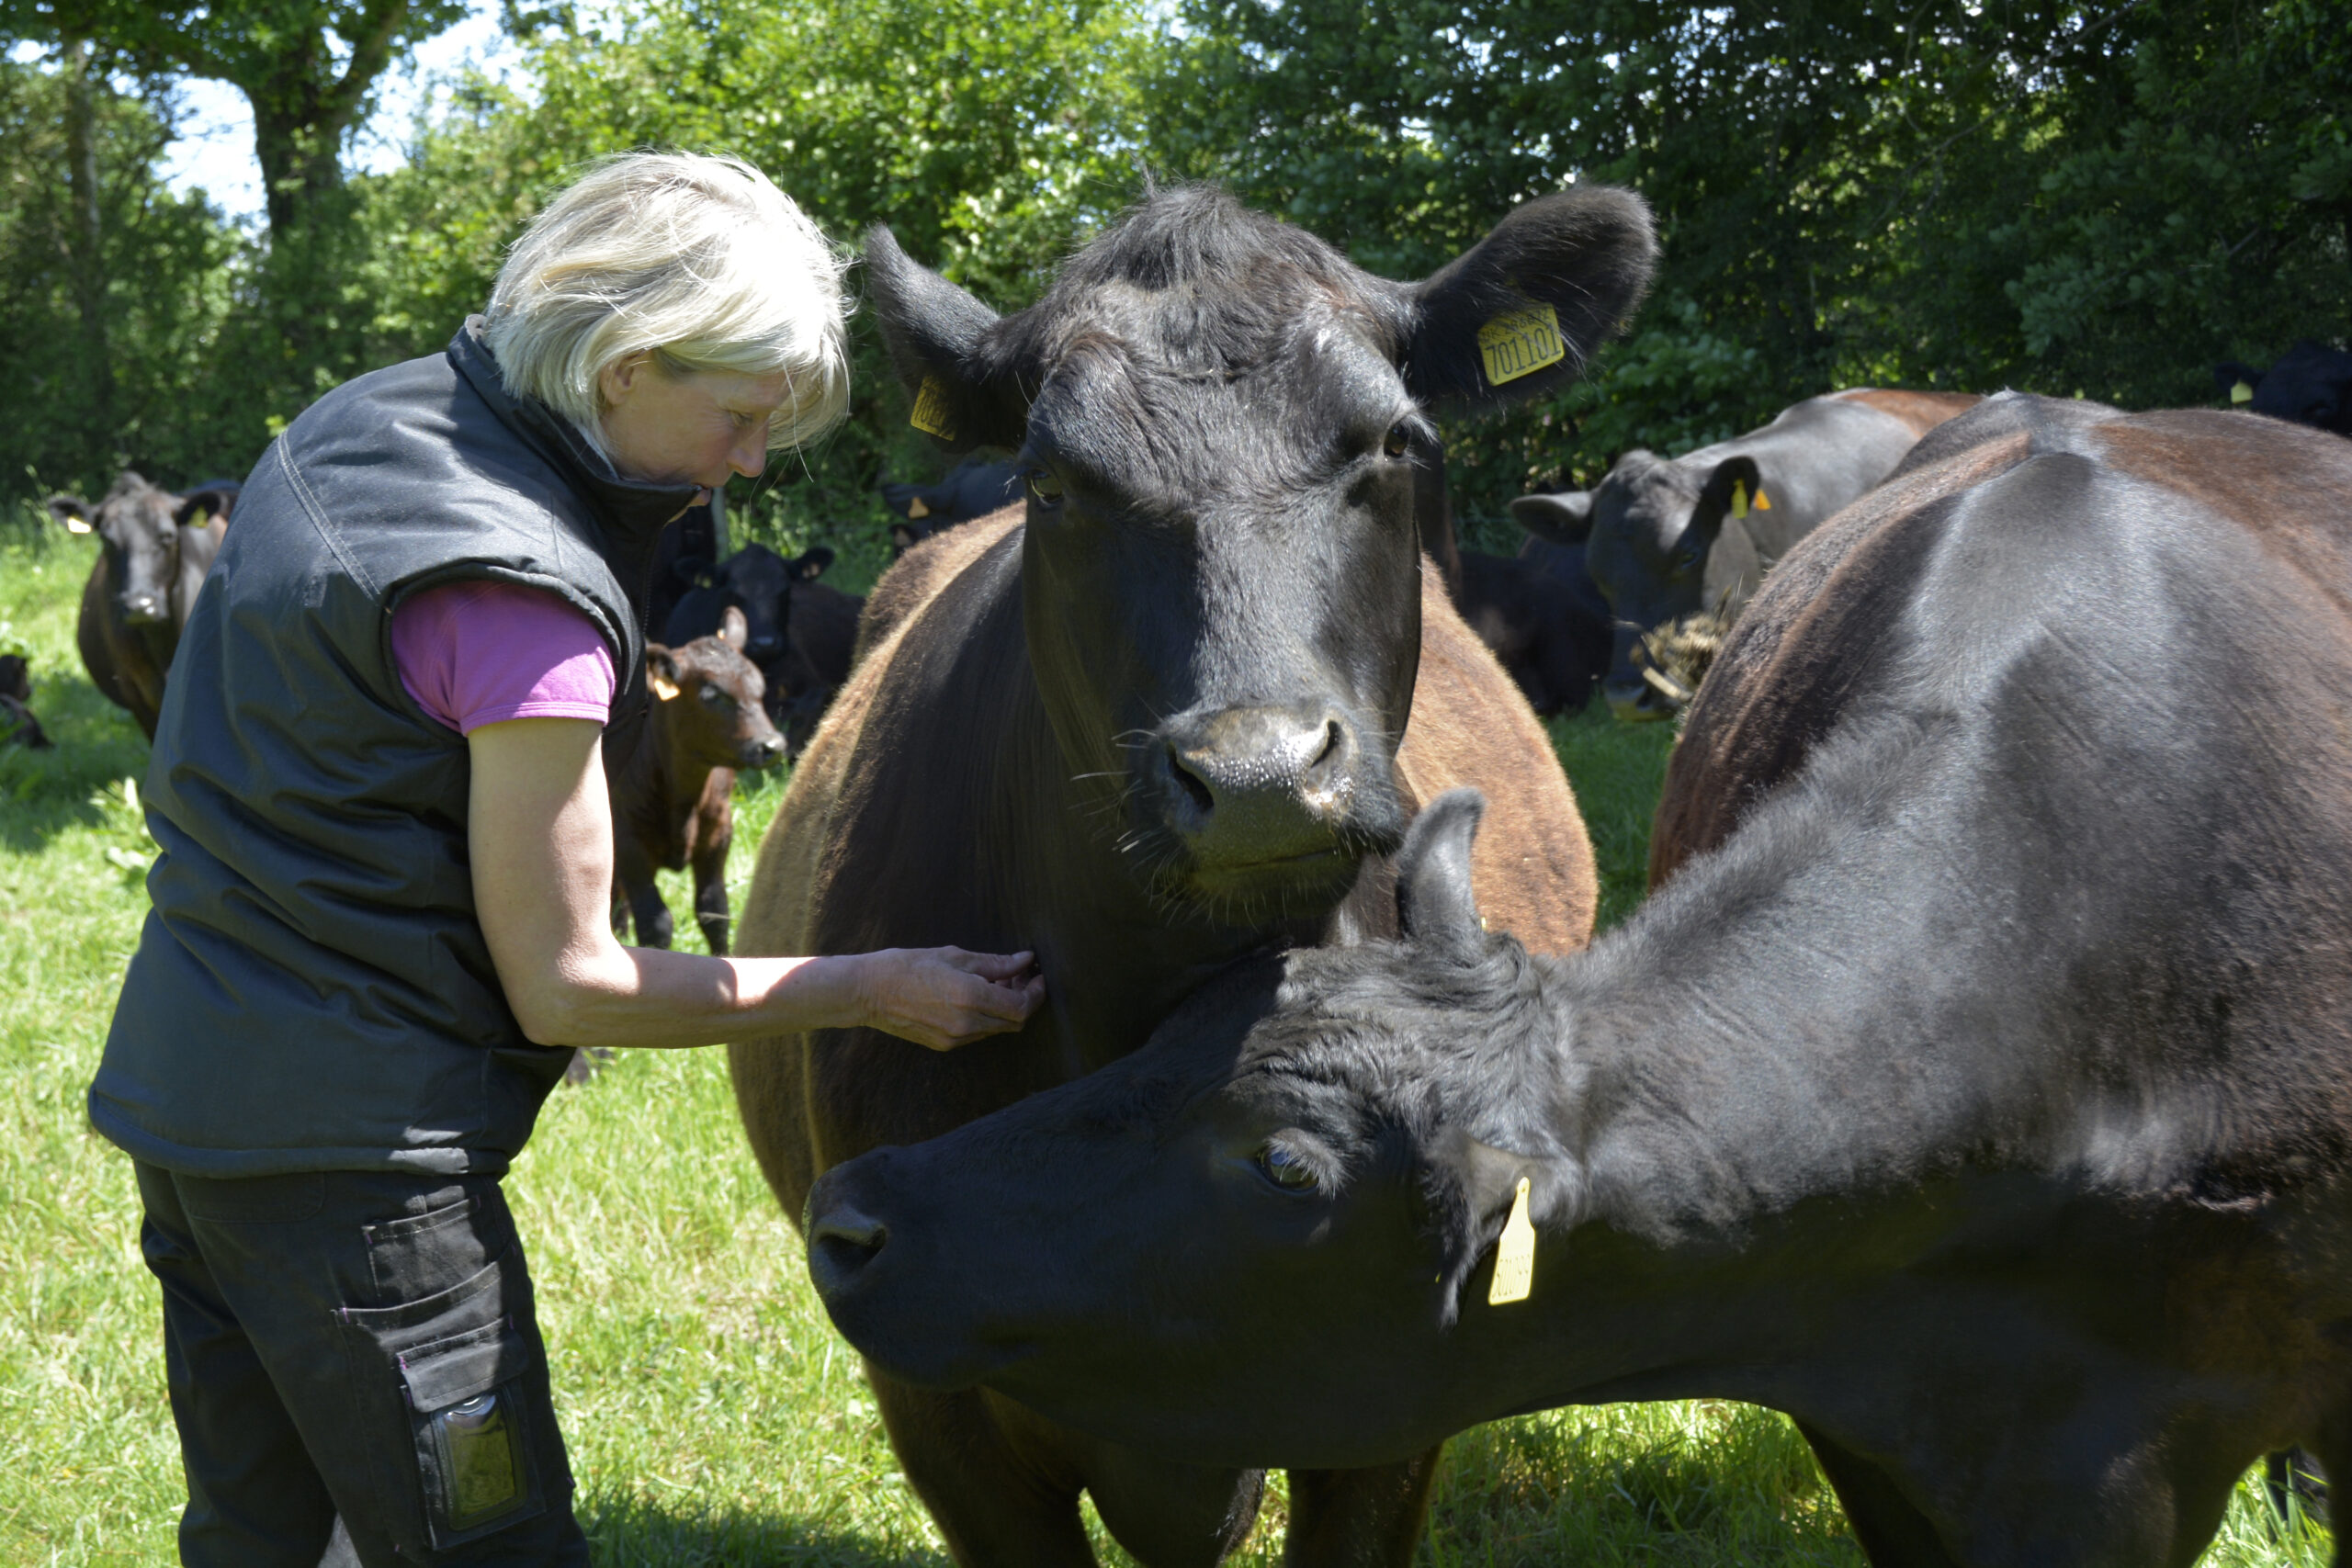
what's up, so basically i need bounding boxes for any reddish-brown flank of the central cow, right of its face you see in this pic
[1397,558,1600,952]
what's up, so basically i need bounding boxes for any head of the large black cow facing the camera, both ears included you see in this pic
[865,188,1654,921]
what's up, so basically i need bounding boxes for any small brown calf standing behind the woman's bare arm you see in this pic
[609,606,783,954]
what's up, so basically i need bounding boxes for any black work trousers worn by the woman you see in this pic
[139,1164,588,1568]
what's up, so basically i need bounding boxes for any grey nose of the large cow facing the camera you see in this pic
[1155,707,1362,865]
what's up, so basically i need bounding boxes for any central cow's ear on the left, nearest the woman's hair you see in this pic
[865,223,1028,451]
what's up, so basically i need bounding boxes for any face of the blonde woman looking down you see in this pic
[597,355,786,502]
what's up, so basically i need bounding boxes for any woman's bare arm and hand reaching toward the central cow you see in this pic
[468,719,1045,1051]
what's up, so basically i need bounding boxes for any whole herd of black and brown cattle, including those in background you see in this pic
[14,177,2352,1568]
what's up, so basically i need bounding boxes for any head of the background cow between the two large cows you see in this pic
[1510,451,1761,719]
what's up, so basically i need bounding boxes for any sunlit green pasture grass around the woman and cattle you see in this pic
[0,525,2331,1568]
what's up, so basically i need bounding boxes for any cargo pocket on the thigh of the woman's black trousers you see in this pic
[336,1253,562,1551]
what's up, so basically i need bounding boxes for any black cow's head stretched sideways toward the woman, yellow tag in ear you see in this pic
[805,790,1585,1467]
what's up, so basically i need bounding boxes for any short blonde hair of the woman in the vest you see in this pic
[482,152,849,456]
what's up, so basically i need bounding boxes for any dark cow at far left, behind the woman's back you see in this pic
[50,468,238,740]
